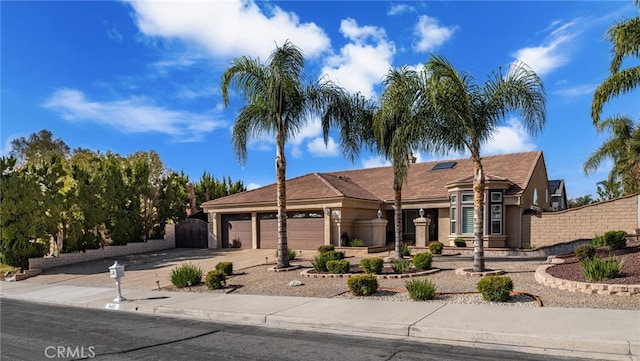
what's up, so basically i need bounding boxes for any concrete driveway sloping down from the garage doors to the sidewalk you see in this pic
[20,248,276,290]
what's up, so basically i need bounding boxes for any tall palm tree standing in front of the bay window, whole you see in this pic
[418,55,546,272]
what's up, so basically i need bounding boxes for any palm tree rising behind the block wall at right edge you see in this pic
[583,115,640,194]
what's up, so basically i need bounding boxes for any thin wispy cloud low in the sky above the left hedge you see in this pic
[43,89,226,142]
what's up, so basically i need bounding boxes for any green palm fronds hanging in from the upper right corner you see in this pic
[591,0,640,126]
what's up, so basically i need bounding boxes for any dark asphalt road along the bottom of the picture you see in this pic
[0,298,592,361]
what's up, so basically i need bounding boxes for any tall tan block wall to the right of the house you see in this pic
[522,194,640,247]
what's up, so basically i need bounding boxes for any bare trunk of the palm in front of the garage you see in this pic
[276,132,289,268]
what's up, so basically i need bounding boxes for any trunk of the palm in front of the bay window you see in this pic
[471,152,485,272]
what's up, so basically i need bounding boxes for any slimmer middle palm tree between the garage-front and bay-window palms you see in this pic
[373,67,423,259]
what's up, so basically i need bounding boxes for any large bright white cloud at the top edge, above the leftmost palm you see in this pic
[129,0,330,59]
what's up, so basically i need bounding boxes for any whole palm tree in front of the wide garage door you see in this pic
[221,41,344,268]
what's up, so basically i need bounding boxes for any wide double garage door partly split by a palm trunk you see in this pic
[258,211,324,250]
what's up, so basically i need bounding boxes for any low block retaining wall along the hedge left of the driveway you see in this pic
[29,224,176,269]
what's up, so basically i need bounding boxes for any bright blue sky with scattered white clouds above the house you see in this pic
[0,0,640,197]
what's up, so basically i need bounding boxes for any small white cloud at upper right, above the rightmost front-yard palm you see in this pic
[511,20,577,76]
